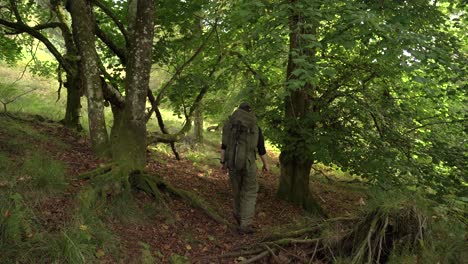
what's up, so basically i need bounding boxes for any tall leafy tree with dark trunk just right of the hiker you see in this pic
[278,0,466,208]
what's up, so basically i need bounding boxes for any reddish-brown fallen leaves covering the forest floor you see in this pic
[0,115,366,263]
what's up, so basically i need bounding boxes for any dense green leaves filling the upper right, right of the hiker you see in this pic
[230,0,467,199]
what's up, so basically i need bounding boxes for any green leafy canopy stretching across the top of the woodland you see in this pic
[0,0,467,204]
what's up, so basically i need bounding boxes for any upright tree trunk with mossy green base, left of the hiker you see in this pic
[112,0,155,173]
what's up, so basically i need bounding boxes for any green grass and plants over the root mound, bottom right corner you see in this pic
[367,190,466,263]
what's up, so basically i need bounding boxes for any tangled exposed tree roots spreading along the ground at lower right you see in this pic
[221,201,448,263]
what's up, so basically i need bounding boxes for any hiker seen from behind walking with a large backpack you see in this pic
[221,103,268,234]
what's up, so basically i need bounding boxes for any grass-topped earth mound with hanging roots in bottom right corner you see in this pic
[338,191,466,264]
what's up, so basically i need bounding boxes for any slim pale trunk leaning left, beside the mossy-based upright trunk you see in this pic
[68,0,109,157]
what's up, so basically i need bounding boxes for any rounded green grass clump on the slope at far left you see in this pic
[23,153,67,190]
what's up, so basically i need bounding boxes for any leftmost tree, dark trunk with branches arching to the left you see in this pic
[0,1,83,129]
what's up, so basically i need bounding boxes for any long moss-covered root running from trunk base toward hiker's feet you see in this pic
[129,173,233,227]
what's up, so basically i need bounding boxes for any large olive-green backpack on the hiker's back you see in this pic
[222,109,259,170]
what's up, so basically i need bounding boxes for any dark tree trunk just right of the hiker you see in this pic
[278,0,322,214]
